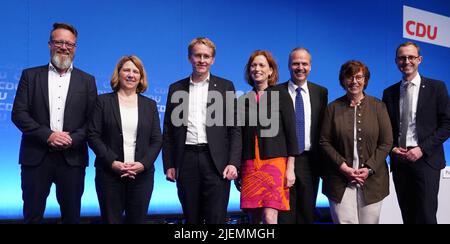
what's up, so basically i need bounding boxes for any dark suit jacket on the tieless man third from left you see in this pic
[163,75,242,175]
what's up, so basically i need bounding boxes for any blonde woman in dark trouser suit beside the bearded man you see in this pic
[88,56,162,224]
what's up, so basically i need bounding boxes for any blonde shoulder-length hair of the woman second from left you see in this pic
[111,55,148,93]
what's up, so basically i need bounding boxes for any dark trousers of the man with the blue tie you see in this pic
[278,152,319,224]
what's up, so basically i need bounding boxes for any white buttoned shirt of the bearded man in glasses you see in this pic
[48,62,73,131]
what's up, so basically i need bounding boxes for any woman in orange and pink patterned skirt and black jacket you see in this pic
[239,50,298,224]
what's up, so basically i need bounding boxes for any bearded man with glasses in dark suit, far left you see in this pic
[12,23,97,224]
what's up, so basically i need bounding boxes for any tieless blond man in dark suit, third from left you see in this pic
[163,37,242,224]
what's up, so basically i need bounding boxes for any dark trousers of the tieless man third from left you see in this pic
[177,146,230,224]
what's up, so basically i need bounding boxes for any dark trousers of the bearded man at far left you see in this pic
[21,152,86,224]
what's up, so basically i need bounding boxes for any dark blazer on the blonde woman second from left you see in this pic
[88,92,162,170]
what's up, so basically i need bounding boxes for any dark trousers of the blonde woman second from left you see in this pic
[95,168,154,224]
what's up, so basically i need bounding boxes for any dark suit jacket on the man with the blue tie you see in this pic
[280,81,328,157]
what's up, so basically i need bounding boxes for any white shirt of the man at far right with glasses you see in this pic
[400,73,422,147]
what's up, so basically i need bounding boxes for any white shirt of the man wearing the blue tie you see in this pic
[288,81,311,151]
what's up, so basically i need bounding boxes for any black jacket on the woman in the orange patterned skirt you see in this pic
[238,86,300,160]
